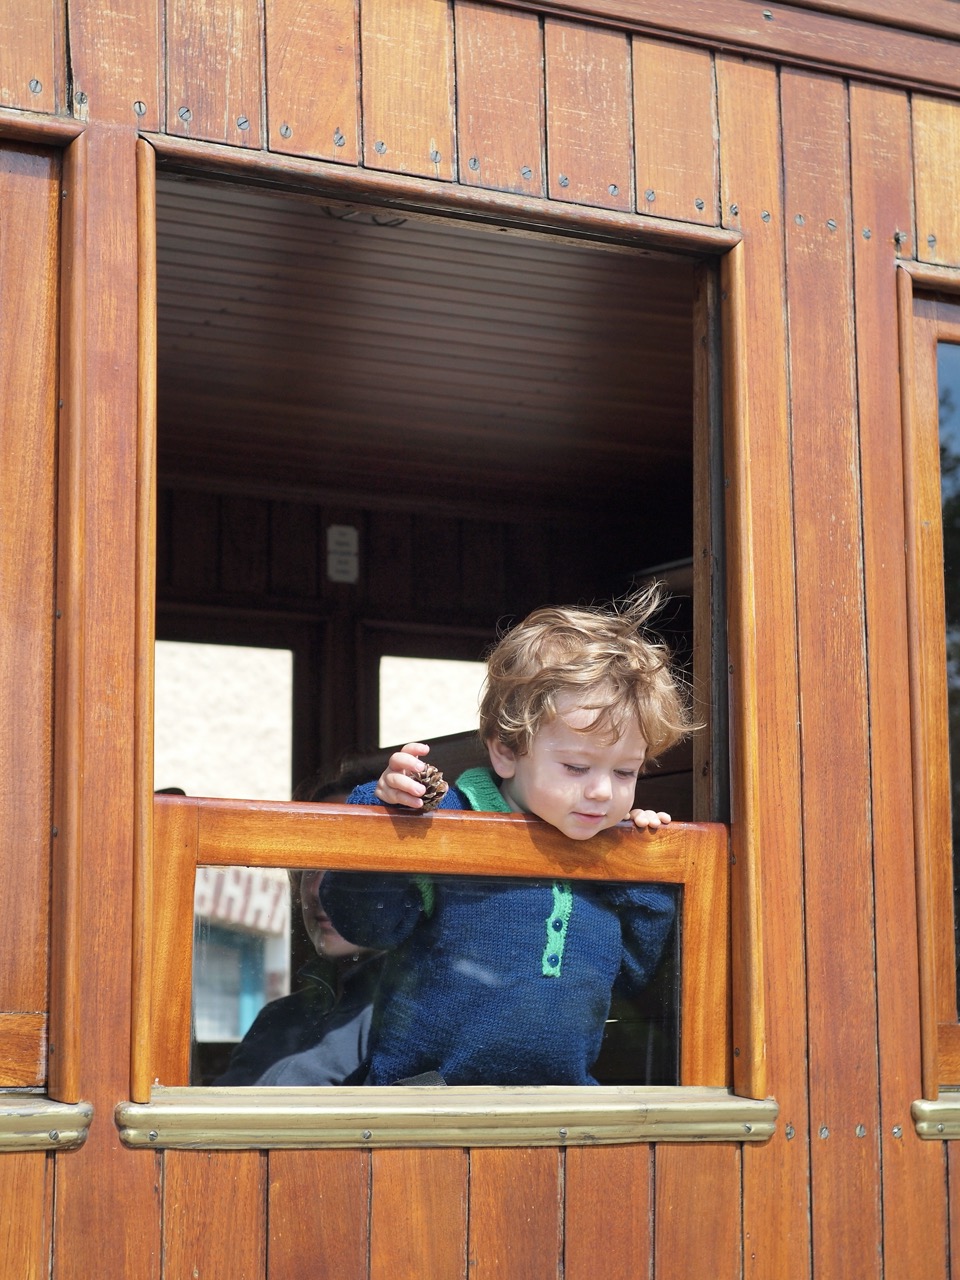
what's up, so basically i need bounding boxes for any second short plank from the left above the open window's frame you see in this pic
[265,0,360,164]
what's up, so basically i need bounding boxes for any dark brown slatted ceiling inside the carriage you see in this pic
[157,175,692,513]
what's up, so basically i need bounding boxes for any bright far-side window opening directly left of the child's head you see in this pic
[379,657,486,746]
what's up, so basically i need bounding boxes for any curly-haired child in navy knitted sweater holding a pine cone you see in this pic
[321,589,692,1084]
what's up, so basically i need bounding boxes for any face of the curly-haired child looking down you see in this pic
[486,703,646,840]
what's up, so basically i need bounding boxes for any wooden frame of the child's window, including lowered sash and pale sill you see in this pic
[116,140,777,1148]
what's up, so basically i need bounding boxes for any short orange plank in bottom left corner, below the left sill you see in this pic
[0,1151,54,1280]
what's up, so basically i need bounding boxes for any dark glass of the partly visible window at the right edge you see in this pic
[937,342,960,1008]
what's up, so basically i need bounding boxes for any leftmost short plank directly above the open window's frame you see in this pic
[166,0,262,147]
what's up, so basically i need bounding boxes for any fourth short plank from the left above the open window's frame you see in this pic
[454,0,544,196]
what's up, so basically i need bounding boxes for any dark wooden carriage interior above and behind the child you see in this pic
[157,174,695,1080]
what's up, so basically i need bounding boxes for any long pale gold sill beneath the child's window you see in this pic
[115,1085,778,1149]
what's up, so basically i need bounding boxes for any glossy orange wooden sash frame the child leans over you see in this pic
[138,796,730,1102]
